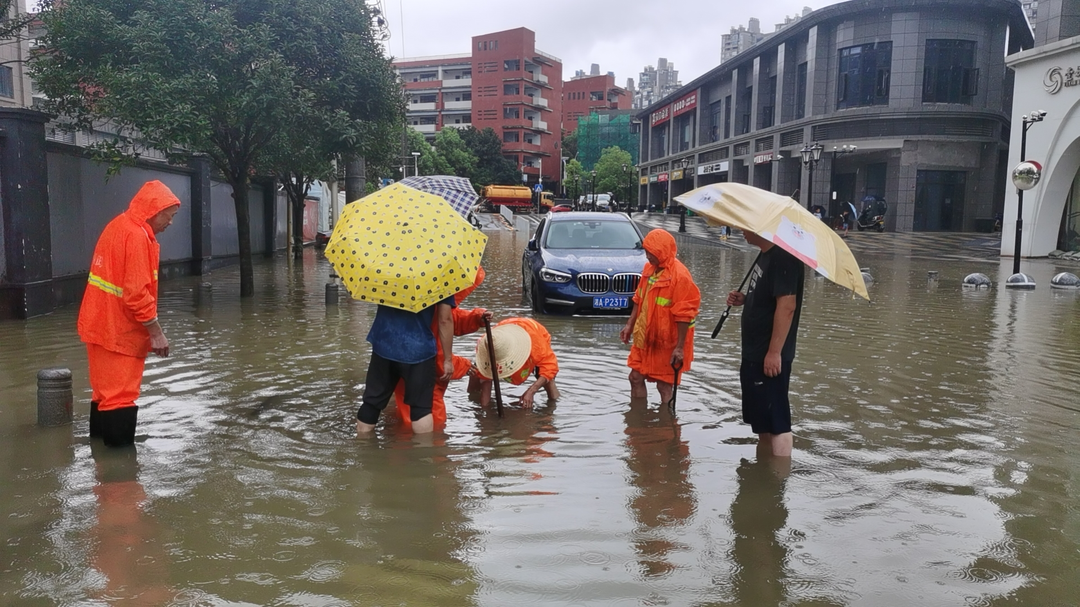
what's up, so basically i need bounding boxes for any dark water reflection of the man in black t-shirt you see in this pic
[731,458,788,605]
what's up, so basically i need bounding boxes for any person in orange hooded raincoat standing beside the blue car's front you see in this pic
[619,229,701,404]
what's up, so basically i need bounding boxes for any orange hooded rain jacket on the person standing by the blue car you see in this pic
[626,229,701,383]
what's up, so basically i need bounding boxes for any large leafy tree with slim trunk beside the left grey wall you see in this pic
[31,0,403,297]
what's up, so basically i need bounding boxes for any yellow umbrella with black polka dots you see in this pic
[326,184,487,312]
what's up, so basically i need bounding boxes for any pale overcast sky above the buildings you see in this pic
[384,0,840,86]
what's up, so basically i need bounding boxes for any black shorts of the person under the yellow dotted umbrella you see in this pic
[356,352,437,423]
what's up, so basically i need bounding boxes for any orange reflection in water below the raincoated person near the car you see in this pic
[625,397,697,577]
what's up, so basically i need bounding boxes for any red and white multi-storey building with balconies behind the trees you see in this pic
[394,27,563,183]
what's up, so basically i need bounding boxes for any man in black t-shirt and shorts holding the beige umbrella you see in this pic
[728,231,804,457]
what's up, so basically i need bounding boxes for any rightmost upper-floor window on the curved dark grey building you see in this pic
[922,40,978,104]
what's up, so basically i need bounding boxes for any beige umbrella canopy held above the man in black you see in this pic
[675,184,870,301]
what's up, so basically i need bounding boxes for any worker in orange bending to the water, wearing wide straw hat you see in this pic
[469,319,558,409]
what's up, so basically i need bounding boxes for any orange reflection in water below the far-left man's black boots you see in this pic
[90,441,173,605]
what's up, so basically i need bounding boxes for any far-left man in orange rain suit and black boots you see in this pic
[79,181,180,447]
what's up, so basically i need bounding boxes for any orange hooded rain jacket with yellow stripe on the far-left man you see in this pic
[79,180,180,359]
